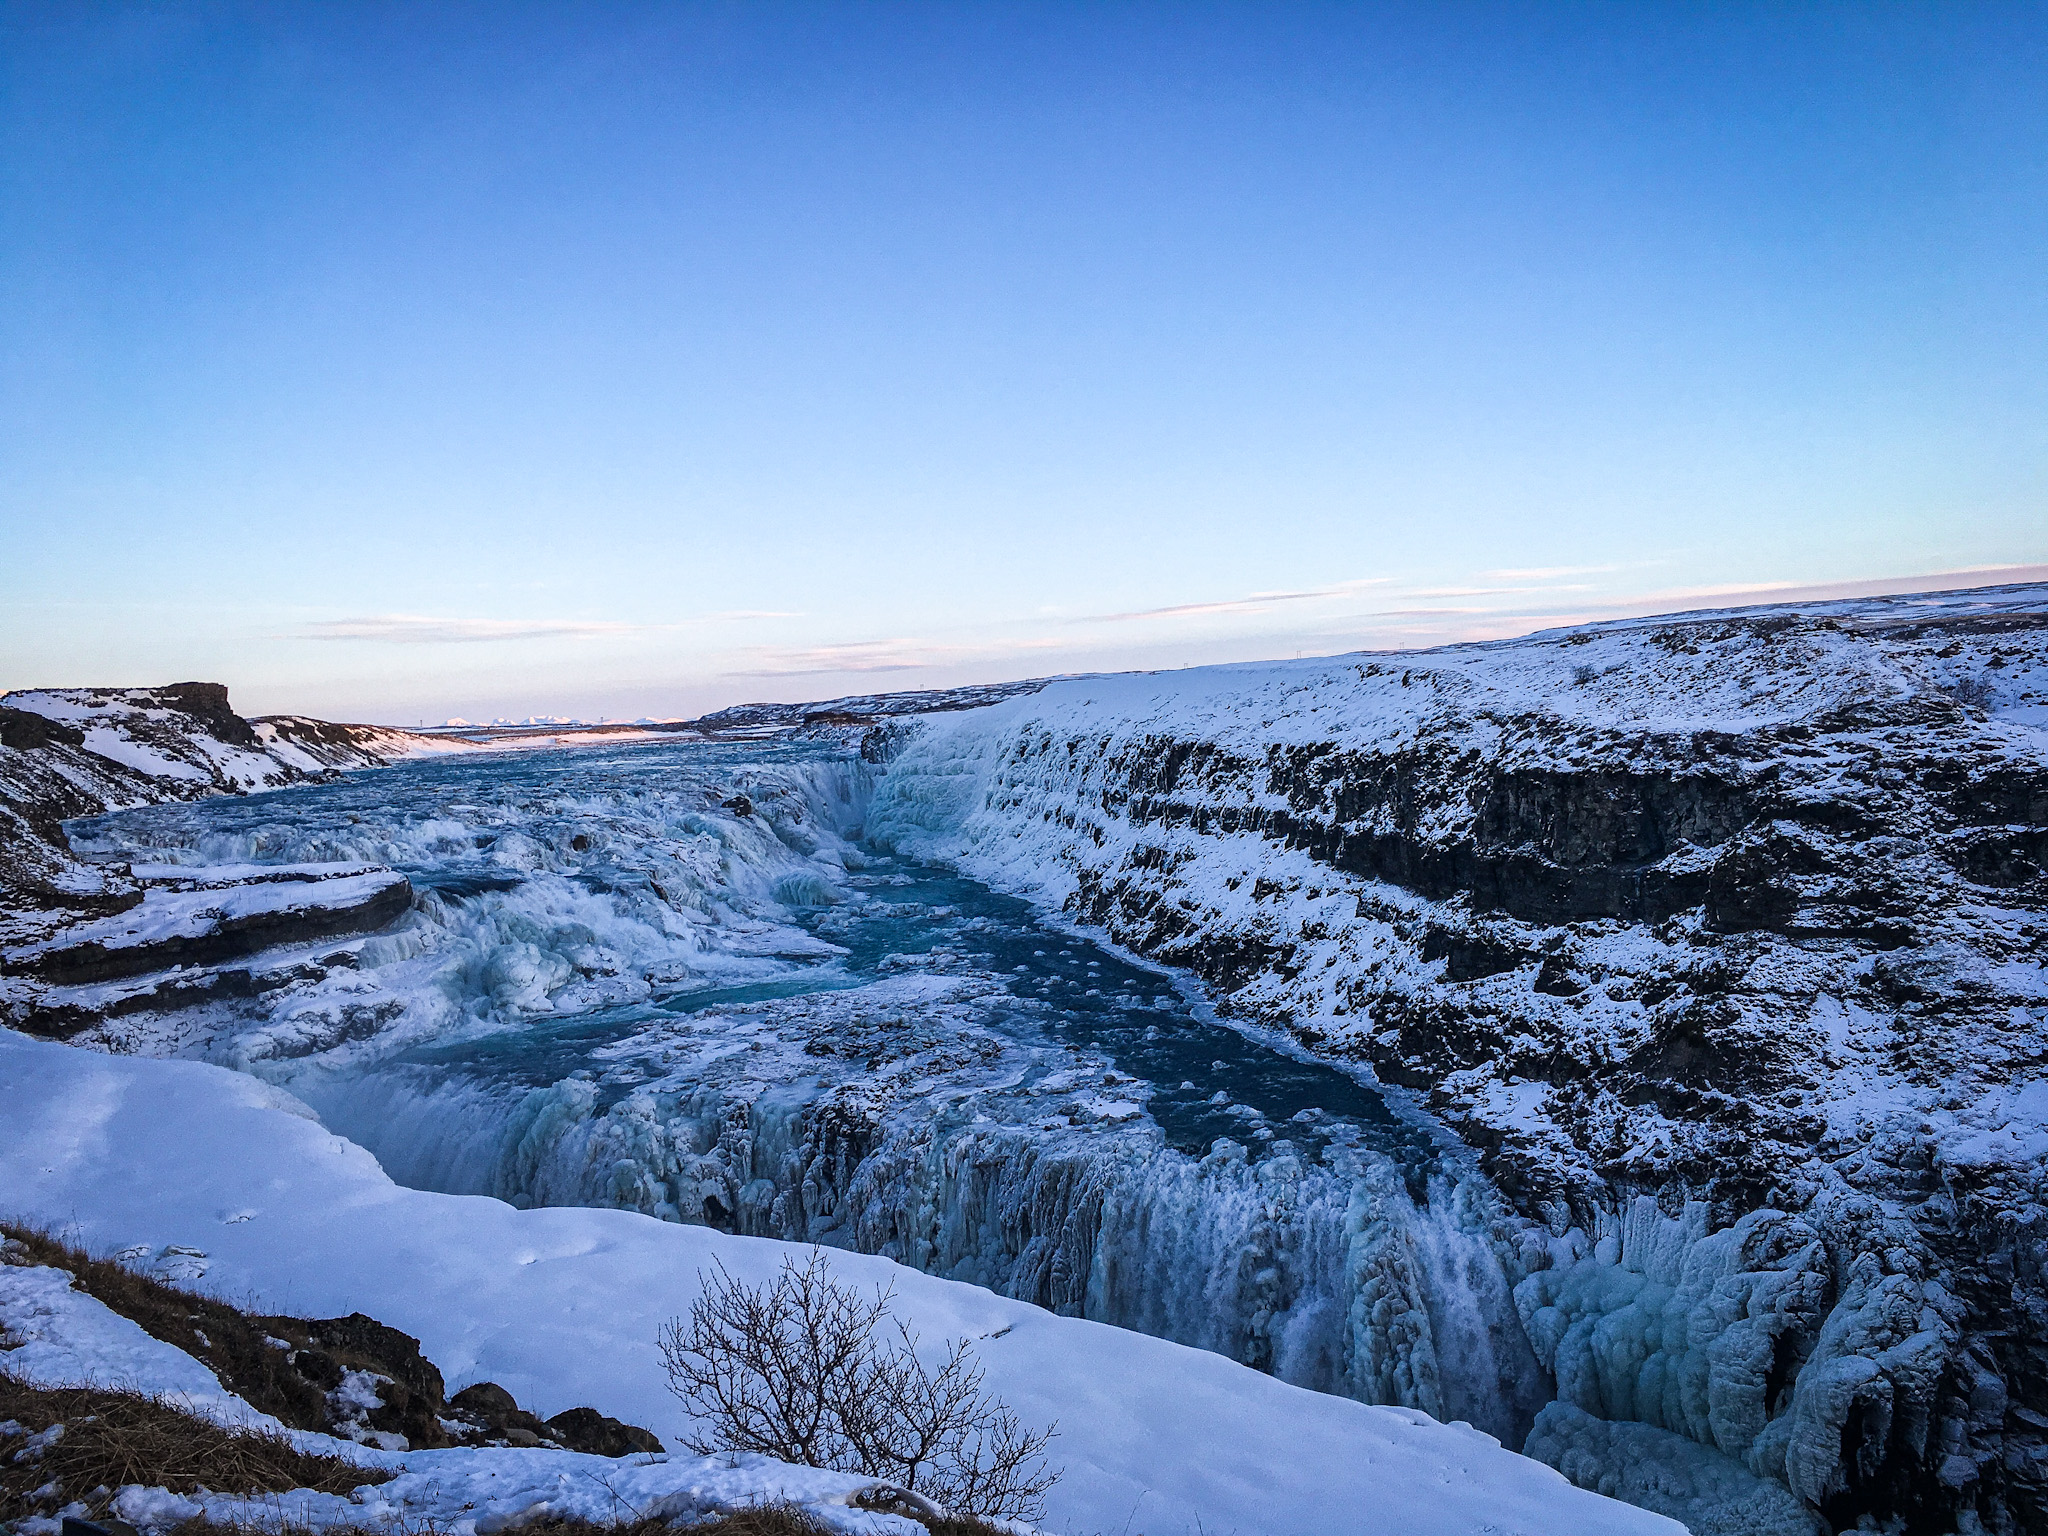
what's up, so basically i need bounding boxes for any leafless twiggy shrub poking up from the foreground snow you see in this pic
[662,1249,1059,1520]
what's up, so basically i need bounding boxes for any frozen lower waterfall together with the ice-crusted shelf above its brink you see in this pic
[301,977,1548,1444]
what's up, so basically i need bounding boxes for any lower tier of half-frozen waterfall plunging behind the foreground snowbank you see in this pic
[299,1067,1550,1446]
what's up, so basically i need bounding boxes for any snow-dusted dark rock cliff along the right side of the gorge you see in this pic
[866,588,2048,1530]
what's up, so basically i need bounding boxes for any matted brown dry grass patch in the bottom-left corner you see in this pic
[0,1374,389,1520]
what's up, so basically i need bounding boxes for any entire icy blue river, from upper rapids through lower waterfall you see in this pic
[74,743,1548,1446]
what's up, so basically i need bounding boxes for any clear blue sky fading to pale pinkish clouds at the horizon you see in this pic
[0,0,2048,723]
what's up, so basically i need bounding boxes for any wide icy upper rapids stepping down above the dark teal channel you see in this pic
[36,745,870,1065]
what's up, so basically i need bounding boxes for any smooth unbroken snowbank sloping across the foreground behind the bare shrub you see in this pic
[0,1032,1679,1536]
